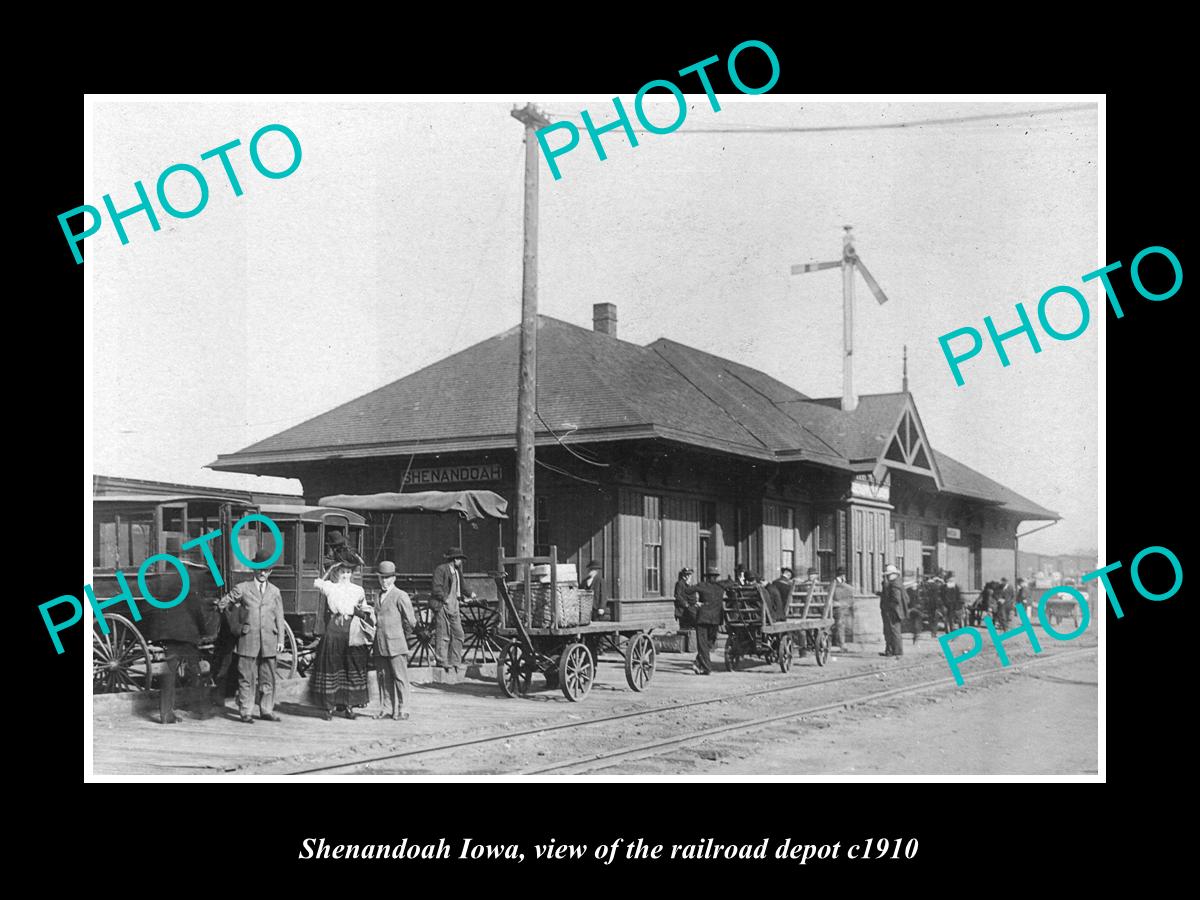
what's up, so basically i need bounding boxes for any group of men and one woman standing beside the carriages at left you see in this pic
[160,535,475,725]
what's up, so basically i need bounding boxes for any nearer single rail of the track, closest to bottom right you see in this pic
[517,644,1097,775]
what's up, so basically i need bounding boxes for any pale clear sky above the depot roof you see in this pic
[84,95,1111,553]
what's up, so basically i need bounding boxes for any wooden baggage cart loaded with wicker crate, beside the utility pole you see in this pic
[496,546,666,701]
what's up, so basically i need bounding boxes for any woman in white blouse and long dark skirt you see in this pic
[310,563,371,720]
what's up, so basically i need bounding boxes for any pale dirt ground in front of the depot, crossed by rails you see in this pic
[92,634,1098,779]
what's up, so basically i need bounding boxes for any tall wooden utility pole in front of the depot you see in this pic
[512,103,550,564]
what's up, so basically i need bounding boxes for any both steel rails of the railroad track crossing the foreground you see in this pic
[284,644,1097,775]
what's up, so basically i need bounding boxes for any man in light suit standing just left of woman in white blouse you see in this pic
[218,550,287,725]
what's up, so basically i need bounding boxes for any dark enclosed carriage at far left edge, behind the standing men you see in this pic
[91,494,299,694]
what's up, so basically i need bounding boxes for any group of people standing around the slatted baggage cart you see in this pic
[674,563,853,676]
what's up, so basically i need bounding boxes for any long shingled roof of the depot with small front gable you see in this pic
[210,316,1056,518]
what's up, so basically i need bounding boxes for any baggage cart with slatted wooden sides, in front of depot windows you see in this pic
[721,583,833,672]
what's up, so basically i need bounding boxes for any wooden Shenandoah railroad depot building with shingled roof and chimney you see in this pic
[210,304,1058,640]
